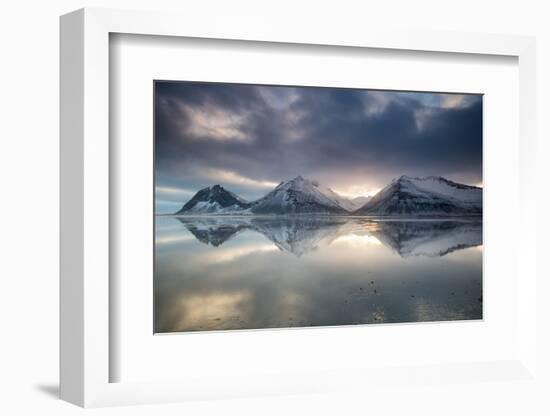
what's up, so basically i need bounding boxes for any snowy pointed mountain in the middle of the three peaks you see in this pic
[250,176,350,215]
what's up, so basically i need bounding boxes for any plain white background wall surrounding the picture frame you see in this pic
[0,0,550,416]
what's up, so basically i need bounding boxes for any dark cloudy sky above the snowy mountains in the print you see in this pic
[155,81,482,212]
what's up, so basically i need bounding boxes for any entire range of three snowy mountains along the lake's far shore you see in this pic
[175,176,482,216]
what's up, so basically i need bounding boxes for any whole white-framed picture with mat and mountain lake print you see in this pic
[61,9,537,406]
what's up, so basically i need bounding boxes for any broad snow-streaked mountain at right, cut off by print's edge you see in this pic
[354,176,483,215]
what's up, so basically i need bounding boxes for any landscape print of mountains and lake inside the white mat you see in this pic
[154,81,483,333]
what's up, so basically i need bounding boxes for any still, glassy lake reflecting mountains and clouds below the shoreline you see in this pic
[154,216,483,333]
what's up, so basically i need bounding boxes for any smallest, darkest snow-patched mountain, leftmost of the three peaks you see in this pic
[176,185,250,215]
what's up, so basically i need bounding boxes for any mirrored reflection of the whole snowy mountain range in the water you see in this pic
[177,217,481,257]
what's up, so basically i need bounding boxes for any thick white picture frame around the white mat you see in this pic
[60,9,537,407]
